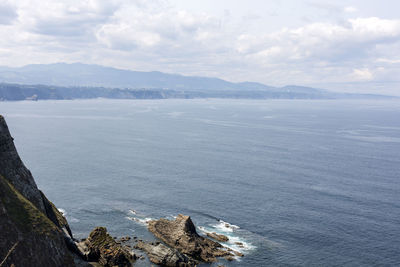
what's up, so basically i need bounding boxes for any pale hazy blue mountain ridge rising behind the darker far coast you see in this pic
[0,63,271,90]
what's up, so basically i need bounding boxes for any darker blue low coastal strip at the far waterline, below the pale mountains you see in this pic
[0,83,396,101]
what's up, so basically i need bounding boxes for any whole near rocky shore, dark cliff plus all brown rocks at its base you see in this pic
[0,115,244,267]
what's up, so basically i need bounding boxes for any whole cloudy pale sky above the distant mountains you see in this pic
[0,0,400,95]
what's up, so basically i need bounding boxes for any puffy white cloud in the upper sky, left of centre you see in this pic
[96,6,219,50]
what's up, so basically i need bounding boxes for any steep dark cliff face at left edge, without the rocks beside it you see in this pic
[0,115,75,266]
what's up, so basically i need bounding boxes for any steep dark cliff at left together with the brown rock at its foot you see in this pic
[0,115,136,267]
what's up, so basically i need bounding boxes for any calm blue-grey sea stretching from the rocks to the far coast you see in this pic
[0,99,400,266]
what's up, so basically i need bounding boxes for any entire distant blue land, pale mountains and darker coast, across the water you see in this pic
[0,63,396,100]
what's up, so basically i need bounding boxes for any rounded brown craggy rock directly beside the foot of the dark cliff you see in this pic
[78,227,136,267]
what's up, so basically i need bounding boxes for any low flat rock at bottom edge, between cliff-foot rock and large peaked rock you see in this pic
[135,241,196,267]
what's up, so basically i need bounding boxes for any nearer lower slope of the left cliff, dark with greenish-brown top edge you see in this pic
[0,175,75,267]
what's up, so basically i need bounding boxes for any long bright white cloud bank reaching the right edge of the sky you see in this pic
[237,17,400,62]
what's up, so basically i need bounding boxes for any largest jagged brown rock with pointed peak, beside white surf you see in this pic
[148,214,233,262]
